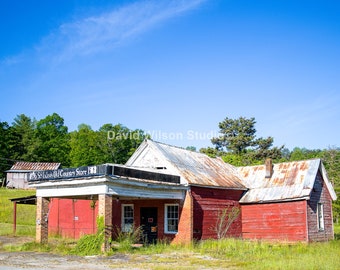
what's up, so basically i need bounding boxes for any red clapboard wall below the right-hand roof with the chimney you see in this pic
[242,201,308,241]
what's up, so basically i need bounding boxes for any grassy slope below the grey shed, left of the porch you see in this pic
[0,188,36,236]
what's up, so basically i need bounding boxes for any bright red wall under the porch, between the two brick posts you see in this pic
[48,198,98,238]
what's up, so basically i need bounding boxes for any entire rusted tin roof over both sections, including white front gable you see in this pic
[126,140,336,199]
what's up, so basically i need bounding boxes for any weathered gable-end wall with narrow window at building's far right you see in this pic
[307,172,334,241]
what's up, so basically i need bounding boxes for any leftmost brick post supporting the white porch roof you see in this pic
[35,197,49,244]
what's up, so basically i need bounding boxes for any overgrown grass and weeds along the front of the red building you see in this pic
[2,230,340,269]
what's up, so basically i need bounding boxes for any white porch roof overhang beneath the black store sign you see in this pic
[30,175,188,199]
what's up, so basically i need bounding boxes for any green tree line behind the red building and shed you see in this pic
[0,113,340,221]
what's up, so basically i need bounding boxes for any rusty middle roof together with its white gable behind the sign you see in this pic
[126,140,247,190]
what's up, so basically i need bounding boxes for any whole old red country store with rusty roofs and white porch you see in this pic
[29,140,336,246]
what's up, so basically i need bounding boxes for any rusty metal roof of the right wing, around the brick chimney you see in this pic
[238,159,336,203]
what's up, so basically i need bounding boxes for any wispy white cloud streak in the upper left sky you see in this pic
[38,0,205,61]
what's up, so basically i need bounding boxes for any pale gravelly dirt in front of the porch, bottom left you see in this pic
[0,236,229,270]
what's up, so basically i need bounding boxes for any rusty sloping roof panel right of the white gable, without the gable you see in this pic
[148,141,246,189]
